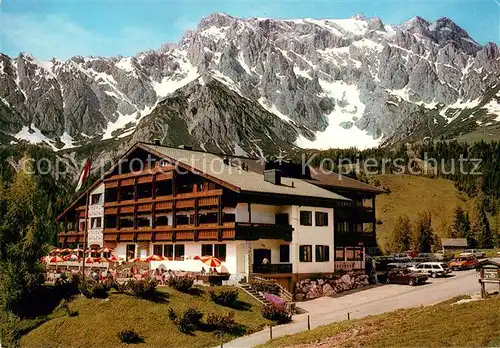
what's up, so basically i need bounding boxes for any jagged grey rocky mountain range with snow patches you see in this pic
[0,14,500,154]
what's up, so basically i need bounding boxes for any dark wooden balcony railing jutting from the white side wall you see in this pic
[236,222,293,242]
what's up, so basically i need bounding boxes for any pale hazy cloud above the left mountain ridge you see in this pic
[0,12,167,59]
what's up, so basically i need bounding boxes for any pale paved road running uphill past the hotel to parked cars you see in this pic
[224,270,498,348]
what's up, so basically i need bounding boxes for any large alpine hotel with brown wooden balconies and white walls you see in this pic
[57,143,383,286]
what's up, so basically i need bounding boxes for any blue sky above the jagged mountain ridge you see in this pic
[0,0,500,59]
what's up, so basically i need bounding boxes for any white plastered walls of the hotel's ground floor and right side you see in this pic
[110,203,335,279]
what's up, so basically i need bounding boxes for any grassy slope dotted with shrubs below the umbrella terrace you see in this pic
[20,287,270,348]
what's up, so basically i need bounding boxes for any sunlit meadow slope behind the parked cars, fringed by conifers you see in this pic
[376,174,471,249]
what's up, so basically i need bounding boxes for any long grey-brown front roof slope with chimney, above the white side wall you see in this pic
[140,143,349,201]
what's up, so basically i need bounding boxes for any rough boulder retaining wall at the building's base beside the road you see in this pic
[295,271,370,301]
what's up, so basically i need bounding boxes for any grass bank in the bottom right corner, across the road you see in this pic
[261,296,500,348]
